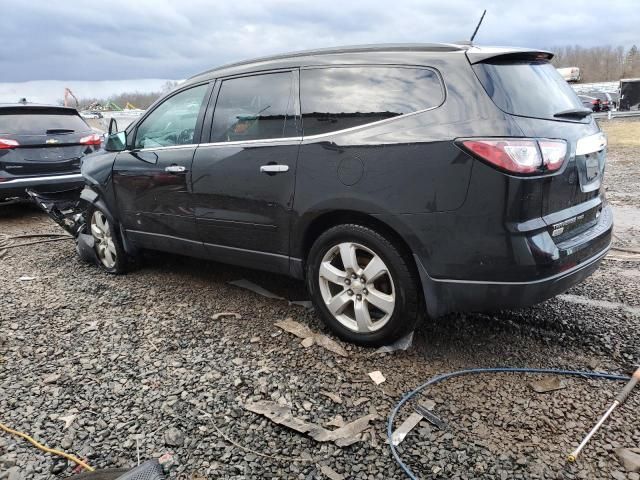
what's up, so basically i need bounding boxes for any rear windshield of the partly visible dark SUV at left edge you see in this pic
[0,110,91,135]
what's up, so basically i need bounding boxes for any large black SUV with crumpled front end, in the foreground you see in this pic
[33,44,612,345]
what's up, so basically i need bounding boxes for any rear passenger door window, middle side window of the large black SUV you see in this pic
[211,72,298,142]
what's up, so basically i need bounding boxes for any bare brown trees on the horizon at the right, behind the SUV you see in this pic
[548,45,640,83]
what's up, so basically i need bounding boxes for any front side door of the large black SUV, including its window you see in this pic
[113,84,209,254]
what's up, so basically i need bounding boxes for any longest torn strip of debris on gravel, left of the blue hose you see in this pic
[244,400,378,447]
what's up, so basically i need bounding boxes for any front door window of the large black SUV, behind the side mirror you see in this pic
[135,85,207,148]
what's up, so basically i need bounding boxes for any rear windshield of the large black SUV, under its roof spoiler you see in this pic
[473,60,583,120]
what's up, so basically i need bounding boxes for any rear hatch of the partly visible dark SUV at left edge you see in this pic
[0,105,99,178]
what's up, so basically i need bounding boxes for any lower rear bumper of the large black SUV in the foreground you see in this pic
[414,206,613,317]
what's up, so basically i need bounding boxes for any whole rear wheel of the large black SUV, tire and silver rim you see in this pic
[306,224,422,346]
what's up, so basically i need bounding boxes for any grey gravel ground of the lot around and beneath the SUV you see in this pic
[0,121,640,480]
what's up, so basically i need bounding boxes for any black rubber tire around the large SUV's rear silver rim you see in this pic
[306,224,423,346]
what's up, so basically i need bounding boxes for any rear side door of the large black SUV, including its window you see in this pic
[192,71,300,273]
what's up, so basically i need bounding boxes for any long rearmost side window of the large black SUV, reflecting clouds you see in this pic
[300,67,444,135]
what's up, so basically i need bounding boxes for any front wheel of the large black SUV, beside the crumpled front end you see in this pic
[87,207,129,274]
